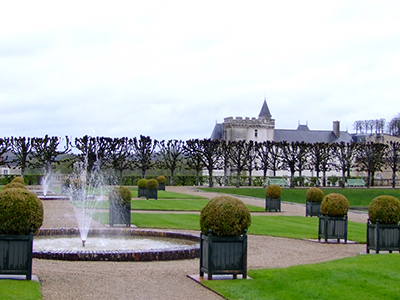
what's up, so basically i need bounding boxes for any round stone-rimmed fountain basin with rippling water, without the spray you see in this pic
[33,228,200,261]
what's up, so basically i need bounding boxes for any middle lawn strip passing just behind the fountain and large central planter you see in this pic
[92,212,366,243]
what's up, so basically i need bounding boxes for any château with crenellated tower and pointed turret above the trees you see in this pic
[211,100,353,143]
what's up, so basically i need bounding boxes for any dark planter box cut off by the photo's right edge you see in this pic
[367,220,400,253]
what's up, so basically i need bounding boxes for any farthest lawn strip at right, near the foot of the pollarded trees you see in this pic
[201,188,400,207]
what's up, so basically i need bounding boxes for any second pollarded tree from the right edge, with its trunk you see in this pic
[356,143,387,187]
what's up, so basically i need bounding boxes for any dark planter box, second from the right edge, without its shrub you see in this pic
[318,215,348,243]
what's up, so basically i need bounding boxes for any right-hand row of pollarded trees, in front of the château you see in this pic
[186,140,400,187]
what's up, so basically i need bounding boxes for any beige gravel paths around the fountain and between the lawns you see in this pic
[33,187,367,300]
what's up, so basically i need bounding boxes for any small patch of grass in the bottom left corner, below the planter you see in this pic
[0,279,42,300]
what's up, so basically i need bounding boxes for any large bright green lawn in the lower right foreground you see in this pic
[203,254,400,300]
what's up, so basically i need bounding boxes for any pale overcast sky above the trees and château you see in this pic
[0,0,400,140]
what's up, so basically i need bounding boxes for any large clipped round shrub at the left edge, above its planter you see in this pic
[0,188,43,235]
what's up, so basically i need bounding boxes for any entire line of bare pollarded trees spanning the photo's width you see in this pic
[0,135,400,187]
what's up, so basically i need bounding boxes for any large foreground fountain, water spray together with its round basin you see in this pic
[33,151,200,261]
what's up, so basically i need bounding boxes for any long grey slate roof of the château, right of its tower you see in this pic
[274,129,353,143]
